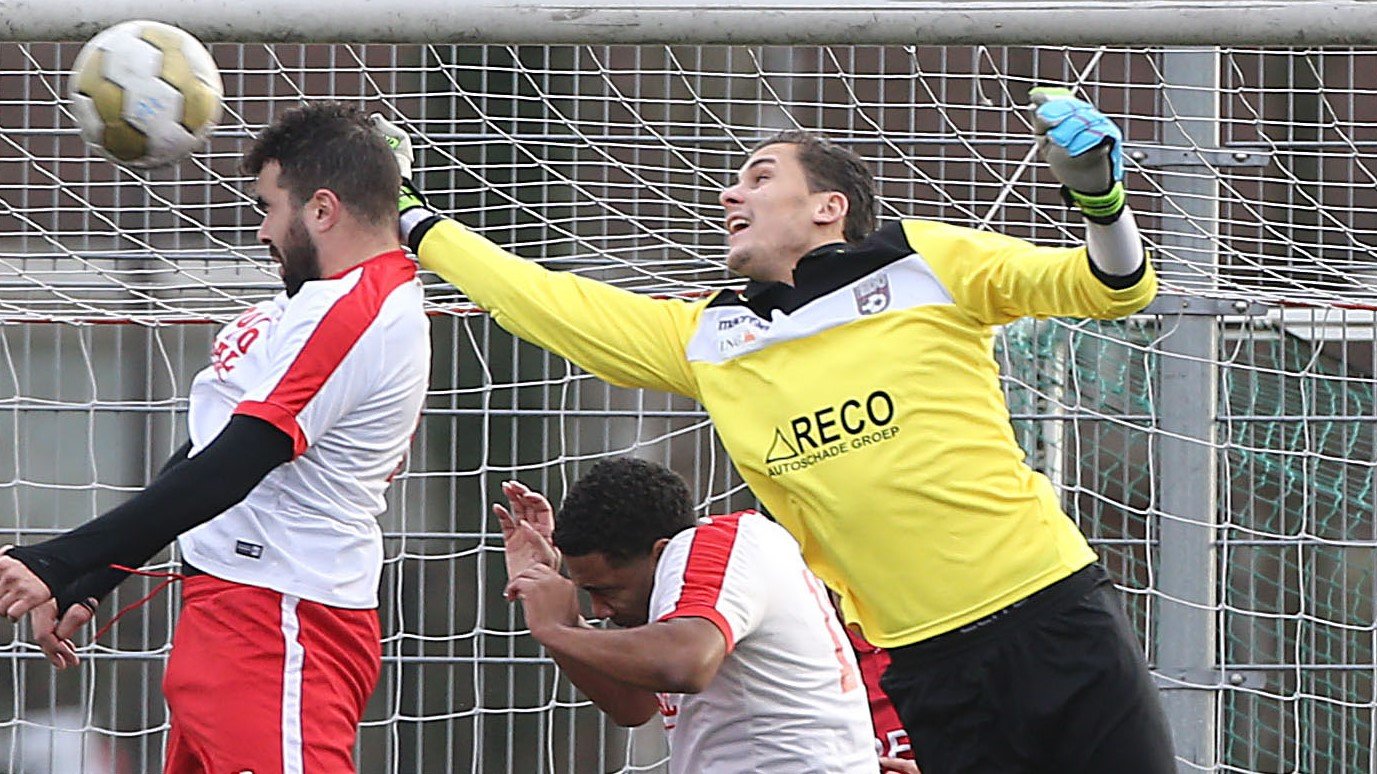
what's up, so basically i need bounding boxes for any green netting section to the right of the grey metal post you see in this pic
[1220,325,1377,771]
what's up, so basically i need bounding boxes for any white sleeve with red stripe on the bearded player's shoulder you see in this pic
[234,272,380,457]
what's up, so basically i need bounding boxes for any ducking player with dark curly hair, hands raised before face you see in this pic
[498,457,877,774]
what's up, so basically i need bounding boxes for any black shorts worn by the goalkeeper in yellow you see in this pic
[880,565,1176,774]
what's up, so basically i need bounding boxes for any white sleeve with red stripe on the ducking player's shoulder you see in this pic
[650,514,768,653]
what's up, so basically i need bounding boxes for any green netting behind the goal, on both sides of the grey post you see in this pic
[998,321,1377,773]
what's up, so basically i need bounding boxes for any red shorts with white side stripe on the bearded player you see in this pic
[162,576,381,774]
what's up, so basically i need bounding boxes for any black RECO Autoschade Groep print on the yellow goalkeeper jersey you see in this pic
[766,390,899,477]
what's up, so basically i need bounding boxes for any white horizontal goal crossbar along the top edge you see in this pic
[8,0,1377,45]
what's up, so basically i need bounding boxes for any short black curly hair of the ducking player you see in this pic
[554,457,695,565]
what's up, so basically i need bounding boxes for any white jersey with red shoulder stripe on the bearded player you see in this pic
[179,251,430,609]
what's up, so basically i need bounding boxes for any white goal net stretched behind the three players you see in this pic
[0,30,1377,773]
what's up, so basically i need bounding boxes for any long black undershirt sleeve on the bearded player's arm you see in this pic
[8,415,292,599]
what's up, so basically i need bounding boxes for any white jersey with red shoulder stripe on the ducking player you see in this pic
[650,511,879,774]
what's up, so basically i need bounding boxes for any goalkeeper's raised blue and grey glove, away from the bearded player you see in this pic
[1029,87,1126,223]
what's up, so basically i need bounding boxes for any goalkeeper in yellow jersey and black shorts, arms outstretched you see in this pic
[375,88,1175,774]
